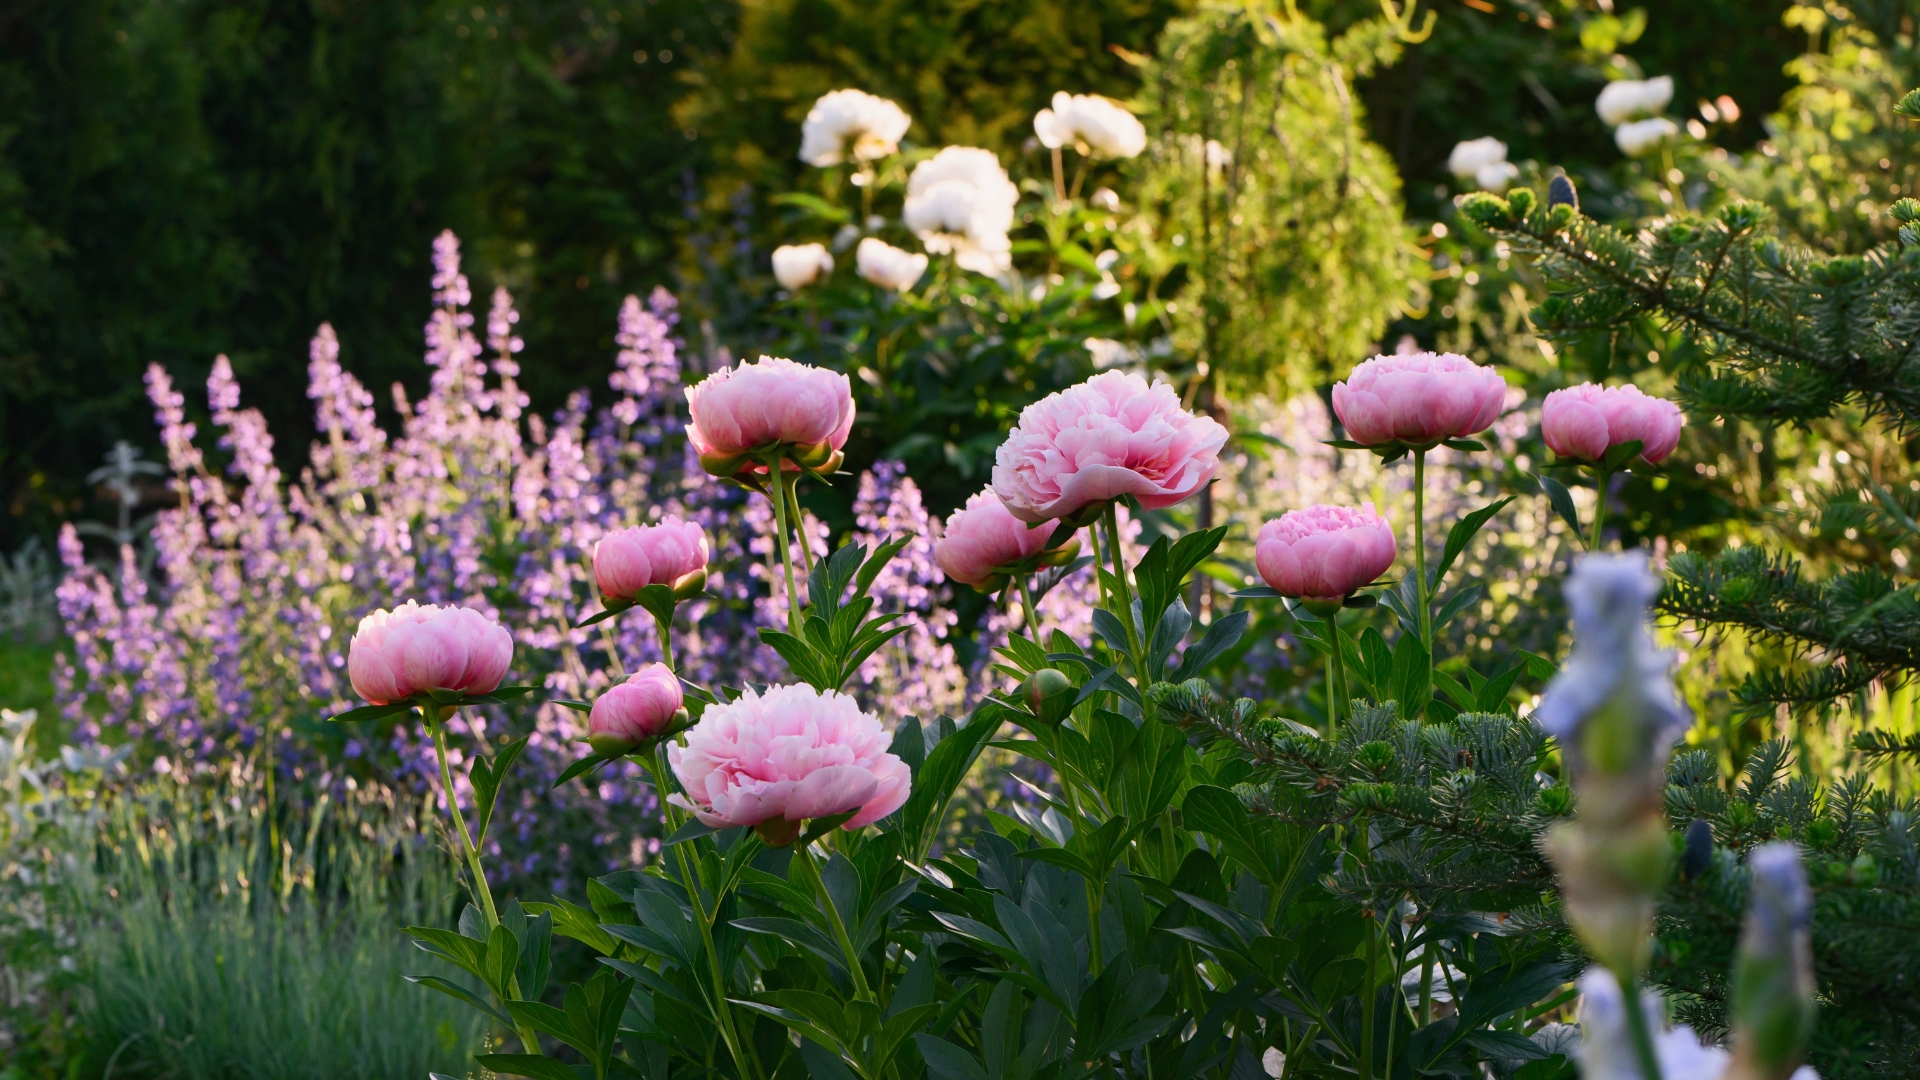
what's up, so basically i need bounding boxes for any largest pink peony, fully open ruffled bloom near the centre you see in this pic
[993,371,1227,521]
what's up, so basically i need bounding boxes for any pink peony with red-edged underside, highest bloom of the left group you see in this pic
[687,356,852,459]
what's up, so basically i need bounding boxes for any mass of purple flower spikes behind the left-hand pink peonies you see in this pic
[56,233,1092,882]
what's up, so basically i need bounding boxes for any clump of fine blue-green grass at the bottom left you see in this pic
[86,772,480,1080]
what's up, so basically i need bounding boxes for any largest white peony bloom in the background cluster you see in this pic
[900,146,1020,275]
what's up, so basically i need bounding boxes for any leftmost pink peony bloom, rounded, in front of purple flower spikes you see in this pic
[348,600,513,705]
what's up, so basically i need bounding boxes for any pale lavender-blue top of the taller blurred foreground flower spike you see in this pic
[1534,552,1692,763]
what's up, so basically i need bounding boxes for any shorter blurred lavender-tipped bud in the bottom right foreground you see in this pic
[1732,842,1814,1080]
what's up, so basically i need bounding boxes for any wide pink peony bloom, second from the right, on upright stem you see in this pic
[1332,352,1507,446]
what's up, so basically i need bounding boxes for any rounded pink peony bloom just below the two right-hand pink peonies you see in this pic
[1254,503,1394,600]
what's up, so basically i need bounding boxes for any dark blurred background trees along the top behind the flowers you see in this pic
[0,0,1804,552]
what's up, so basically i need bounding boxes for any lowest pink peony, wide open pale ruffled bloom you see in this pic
[666,686,912,844]
